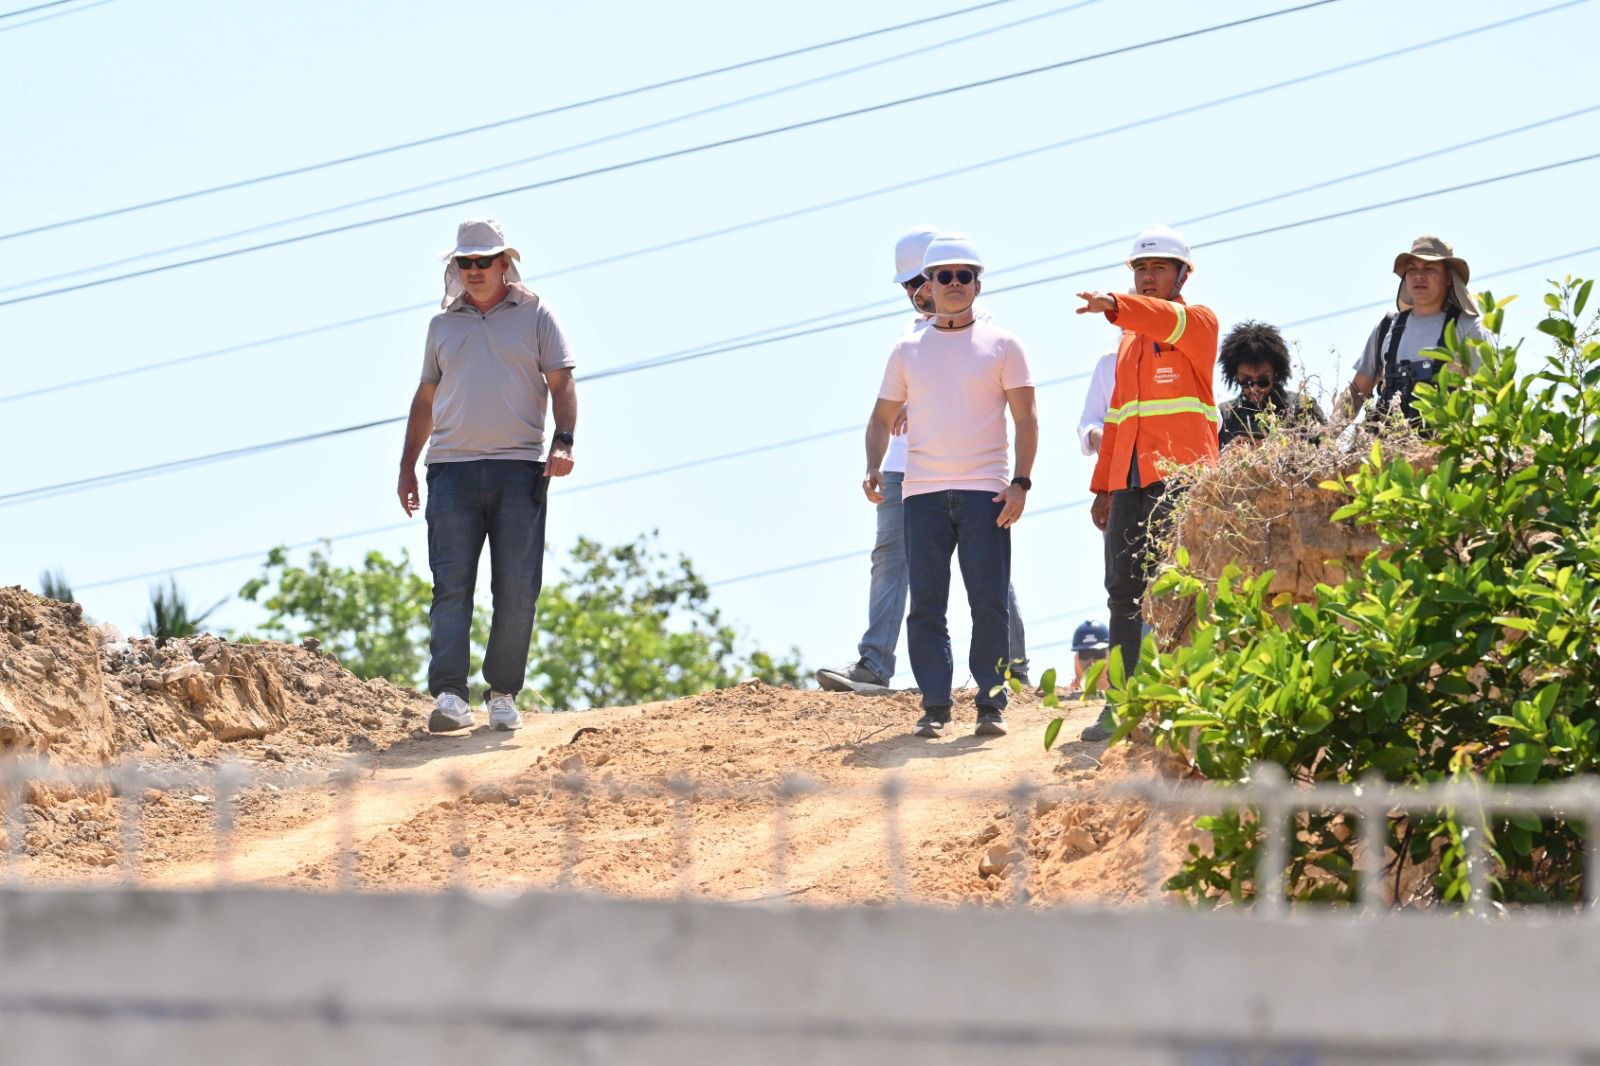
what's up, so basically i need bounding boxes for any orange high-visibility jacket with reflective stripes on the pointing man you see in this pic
[1090,293,1219,493]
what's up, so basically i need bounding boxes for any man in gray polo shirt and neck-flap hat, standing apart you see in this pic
[400,219,578,733]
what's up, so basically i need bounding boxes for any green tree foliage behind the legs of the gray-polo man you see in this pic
[240,535,800,709]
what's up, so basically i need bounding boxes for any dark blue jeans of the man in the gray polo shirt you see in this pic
[427,459,547,699]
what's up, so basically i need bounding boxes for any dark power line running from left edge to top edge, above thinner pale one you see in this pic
[0,0,1014,240]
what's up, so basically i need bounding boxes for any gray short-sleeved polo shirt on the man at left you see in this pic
[422,285,576,463]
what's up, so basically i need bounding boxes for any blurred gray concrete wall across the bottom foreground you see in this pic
[0,890,1600,1066]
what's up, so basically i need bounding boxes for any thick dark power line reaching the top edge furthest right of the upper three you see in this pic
[0,0,1350,307]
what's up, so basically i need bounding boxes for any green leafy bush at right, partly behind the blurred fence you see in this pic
[1109,279,1600,901]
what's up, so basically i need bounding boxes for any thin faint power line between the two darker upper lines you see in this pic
[15,0,1102,293]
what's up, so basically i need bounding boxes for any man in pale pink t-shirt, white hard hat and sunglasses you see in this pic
[862,234,1038,736]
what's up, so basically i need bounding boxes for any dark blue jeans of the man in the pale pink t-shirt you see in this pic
[902,491,1011,709]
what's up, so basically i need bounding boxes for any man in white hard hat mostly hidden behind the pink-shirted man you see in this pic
[816,226,1029,696]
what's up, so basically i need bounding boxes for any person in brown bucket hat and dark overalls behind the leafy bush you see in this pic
[1342,235,1490,421]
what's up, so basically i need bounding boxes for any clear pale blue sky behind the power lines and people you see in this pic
[0,0,1600,685]
